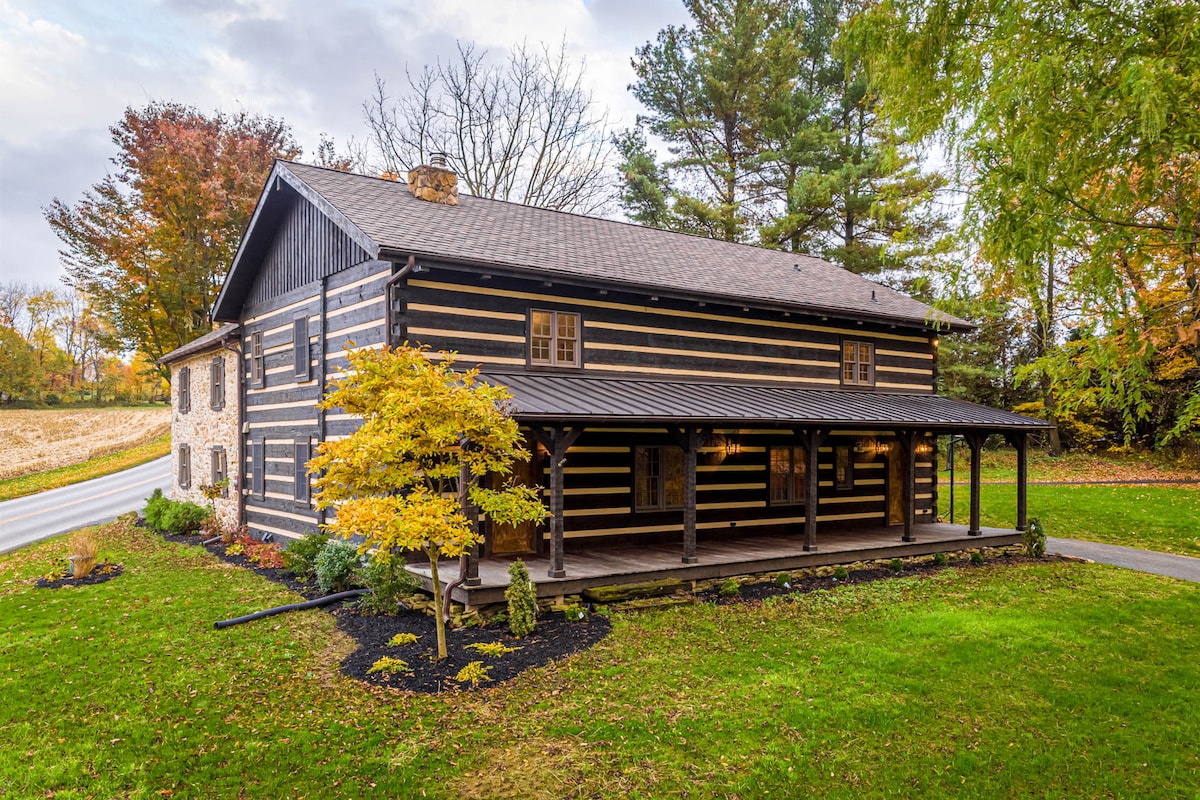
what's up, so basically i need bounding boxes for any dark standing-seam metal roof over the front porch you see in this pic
[484,372,1051,431]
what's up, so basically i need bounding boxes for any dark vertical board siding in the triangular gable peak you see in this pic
[246,193,368,306]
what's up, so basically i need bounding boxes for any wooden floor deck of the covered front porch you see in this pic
[408,523,1021,606]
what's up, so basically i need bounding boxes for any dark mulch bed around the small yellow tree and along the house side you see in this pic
[141,533,612,693]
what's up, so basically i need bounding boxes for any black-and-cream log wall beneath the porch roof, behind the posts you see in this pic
[542,427,936,551]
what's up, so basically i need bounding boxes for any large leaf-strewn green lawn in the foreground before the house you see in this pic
[0,524,1200,800]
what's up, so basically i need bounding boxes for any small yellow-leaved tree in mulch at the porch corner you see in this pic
[308,344,546,658]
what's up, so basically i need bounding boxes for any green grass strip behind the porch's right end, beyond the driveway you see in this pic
[938,485,1200,557]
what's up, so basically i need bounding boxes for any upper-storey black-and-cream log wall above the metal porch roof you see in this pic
[406,269,934,392]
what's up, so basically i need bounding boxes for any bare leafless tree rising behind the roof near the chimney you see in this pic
[362,43,613,213]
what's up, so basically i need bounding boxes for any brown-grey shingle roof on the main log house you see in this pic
[277,162,970,329]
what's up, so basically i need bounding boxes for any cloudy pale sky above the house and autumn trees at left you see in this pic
[0,0,688,285]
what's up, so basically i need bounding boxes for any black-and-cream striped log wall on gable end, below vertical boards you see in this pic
[242,260,392,537]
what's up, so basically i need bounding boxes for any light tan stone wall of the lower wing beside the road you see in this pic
[170,348,241,527]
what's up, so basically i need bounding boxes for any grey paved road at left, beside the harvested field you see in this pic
[0,456,170,553]
